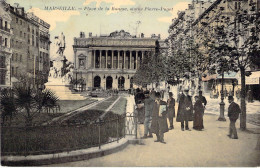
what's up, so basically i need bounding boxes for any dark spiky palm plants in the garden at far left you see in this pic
[1,76,58,126]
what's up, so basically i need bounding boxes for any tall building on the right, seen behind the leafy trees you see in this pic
[168,0,260,99]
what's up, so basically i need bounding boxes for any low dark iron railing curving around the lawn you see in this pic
[1,113,137,156]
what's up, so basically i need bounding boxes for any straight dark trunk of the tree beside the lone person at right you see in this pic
[240,67,246,130]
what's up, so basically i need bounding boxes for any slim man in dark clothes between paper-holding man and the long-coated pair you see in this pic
[167,92,175,130]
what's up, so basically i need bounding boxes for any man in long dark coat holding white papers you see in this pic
[151,92,168,144]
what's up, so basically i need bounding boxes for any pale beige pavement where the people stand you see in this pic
[49,110,260,167]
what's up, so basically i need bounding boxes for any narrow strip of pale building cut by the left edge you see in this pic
[0,0,12,88]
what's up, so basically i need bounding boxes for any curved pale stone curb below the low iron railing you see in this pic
[1,136,140,166]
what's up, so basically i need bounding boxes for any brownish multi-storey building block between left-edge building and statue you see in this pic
[10,4,50,86]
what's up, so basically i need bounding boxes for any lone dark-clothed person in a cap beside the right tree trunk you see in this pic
[228,96,241,139]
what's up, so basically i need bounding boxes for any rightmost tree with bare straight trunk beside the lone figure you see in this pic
[204,0,260,130]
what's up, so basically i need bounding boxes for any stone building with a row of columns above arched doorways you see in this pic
[73,30,160,90]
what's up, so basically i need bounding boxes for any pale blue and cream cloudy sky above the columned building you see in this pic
[6,0,191,62]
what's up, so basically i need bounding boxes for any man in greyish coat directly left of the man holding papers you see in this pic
[142,91,154,139]
